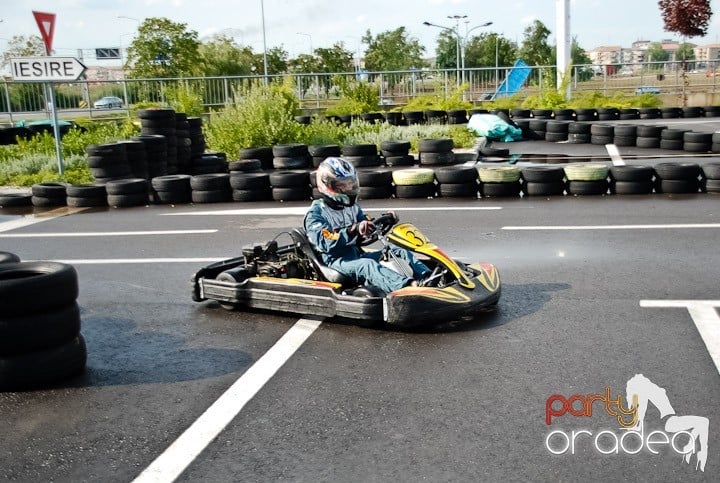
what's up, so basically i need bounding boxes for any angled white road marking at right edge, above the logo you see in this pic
[640,300,720,374]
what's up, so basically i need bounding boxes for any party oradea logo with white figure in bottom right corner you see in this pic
[545,374,710,472]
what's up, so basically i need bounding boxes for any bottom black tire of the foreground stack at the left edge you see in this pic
[0,335,87,391]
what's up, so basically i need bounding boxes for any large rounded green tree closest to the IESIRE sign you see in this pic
[125,17,201,78]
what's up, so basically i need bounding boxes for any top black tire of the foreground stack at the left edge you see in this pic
[0,262,78,317]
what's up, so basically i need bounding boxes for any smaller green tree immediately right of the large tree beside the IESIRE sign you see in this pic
[198,35,253,77]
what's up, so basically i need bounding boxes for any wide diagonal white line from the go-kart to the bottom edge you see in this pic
[133,319,322,483]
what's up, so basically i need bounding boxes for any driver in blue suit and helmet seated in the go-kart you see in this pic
[305,157,430,293]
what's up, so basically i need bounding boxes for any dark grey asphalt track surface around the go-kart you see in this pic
[0,123,720,482]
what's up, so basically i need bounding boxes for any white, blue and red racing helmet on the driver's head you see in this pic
[315,157,360,210]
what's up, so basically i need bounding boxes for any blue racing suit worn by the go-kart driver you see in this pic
[305,200,430,293]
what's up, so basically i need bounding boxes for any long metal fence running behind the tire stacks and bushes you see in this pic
[0,62,718,122]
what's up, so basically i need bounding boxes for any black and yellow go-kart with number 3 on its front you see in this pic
[191,214,500,328]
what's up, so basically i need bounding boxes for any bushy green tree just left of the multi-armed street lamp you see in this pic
[362,27,425,71]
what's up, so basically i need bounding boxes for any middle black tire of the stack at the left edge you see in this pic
[0,302,80,357]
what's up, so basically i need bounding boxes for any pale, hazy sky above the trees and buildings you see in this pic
[0,0,720,65]
